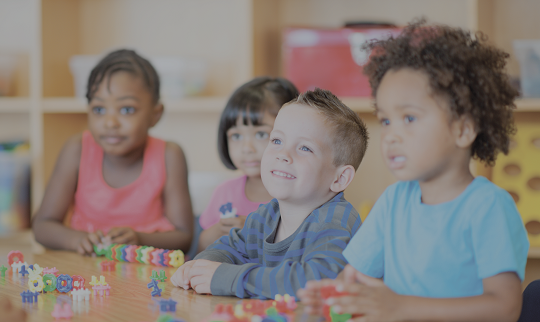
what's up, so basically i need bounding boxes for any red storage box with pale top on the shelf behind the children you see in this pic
[283,28,401,97]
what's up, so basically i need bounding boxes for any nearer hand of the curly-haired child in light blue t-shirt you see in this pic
[326,271,402,322]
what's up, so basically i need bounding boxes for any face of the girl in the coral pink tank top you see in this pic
[88,72,162,156]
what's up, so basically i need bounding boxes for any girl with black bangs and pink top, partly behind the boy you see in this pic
[198,77,298,251]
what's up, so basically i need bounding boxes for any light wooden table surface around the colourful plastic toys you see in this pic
[0,232,324,322]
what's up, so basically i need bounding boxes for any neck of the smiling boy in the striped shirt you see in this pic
[278,191,336,238]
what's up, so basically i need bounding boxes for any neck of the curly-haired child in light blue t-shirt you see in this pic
[419,158,474,205]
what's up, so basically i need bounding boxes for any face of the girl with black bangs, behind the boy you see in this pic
[227,112,276,177]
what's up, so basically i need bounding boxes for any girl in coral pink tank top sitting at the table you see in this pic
[33,50,193,254]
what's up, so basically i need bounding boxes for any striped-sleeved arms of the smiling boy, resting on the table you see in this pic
[187,223,351,299]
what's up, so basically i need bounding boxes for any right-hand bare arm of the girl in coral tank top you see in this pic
[108,142,193,252]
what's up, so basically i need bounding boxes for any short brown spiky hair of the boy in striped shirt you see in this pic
[284,88,369,170]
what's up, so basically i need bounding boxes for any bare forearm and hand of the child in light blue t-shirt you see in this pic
[328,272,522,322]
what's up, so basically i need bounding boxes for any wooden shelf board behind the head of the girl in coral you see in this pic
[42,97,227,113]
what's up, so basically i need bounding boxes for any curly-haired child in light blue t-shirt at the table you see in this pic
[298,22,529,321]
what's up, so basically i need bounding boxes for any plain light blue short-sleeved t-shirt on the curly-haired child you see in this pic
[343,177,529,297]
